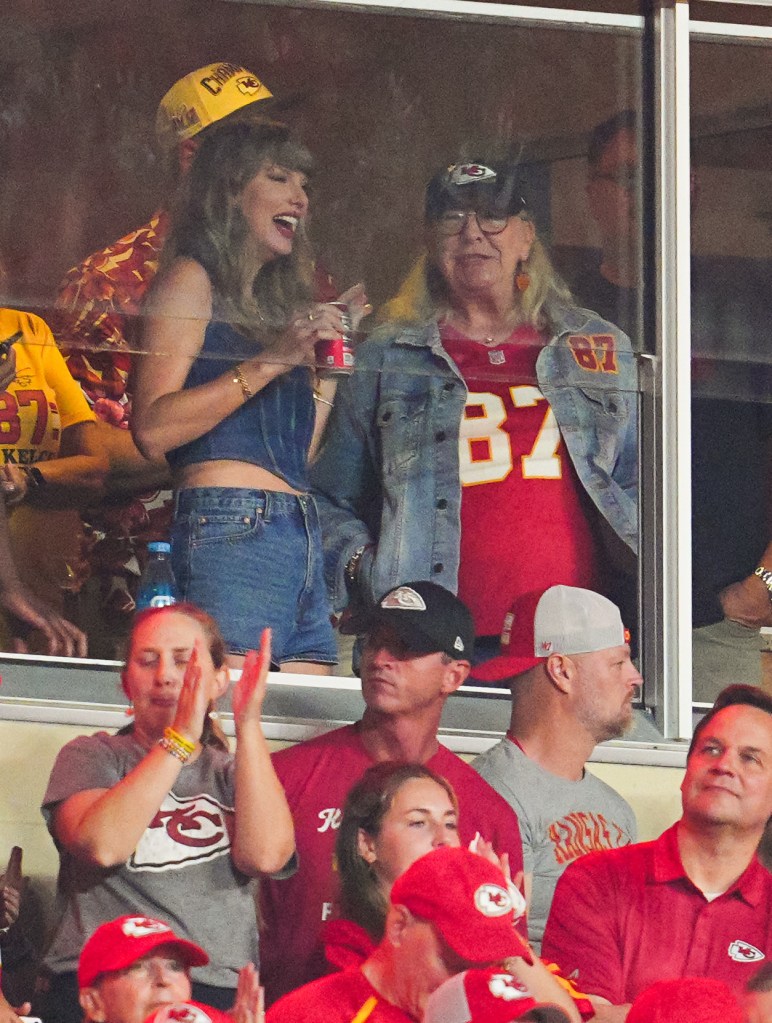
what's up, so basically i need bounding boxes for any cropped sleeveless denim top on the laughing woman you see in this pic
[167,320,316,491]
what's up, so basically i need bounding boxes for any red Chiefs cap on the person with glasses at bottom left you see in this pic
[78,916,209,987]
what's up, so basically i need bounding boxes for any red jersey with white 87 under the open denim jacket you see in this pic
[441,324,598,635]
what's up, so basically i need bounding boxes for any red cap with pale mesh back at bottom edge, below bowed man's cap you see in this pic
[423,970,569,1023]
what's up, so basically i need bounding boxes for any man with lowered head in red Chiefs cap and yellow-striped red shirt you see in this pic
[266,847,535,1023]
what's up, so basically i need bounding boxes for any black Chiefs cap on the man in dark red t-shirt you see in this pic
[340,581,474,661]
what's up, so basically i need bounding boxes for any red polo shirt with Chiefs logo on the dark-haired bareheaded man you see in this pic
[542,825,772,1005]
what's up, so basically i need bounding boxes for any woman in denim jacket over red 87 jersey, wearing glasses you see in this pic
[312,151,638,658]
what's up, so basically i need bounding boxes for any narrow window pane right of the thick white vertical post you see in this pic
[691,29,772,702]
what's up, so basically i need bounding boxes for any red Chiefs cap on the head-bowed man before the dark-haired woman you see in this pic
[392,847,533,965]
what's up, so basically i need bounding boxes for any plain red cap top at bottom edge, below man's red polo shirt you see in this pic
[627,977,743,1023]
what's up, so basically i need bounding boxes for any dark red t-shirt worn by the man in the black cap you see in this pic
[260,725,526,1005]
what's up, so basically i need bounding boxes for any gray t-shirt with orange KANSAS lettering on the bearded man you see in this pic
[472,738,637,951]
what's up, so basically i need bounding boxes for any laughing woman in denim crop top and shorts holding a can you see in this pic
[132,122,364,674]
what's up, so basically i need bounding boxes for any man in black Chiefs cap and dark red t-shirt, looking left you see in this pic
[261,582,523,1004]
